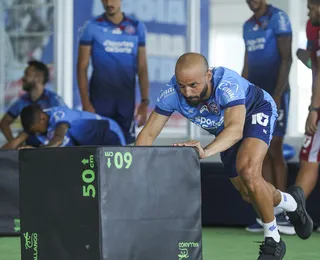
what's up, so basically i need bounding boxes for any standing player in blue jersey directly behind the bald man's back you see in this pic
[242,0,294,234]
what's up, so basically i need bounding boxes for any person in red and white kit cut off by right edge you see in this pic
[296,0,320,222]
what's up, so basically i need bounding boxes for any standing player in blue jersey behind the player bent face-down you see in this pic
[78,0,149,144]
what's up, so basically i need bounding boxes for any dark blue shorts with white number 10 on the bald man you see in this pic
[220,101,277,178]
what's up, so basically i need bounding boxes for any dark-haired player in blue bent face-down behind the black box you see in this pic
[10,105,126,148]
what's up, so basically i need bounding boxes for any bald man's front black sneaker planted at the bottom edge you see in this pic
[258,237,286,260]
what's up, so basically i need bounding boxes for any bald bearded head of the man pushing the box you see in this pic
[175,53,212,106]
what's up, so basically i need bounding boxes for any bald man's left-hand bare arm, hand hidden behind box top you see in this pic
[135,111,170,146]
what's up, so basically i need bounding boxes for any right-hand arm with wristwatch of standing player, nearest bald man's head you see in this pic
[136,22,149,127]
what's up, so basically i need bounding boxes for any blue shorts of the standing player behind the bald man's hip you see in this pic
[273,91,290,136]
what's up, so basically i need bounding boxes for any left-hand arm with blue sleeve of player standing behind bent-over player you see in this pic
[77,22,95,113]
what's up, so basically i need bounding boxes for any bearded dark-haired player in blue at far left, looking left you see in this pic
[0,61,66,149]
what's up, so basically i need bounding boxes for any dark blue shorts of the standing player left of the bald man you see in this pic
[91,98,136,144]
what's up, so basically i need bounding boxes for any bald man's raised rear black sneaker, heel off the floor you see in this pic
[286,186,313,239]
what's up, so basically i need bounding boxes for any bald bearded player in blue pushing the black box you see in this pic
[136,53,313,260]
